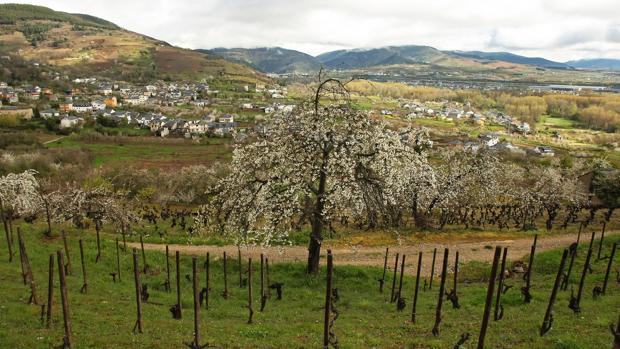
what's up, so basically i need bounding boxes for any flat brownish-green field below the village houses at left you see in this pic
[47,136,231,168]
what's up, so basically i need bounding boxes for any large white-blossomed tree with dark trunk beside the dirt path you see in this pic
[198,79,432,273]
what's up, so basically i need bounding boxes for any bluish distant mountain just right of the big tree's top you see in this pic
[316,45,448,70]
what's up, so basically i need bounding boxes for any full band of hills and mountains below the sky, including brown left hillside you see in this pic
[0,4,620,83]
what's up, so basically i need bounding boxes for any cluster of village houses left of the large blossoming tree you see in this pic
[0,77,294,138]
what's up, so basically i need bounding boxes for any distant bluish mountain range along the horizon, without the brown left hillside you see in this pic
[205,45,620,74]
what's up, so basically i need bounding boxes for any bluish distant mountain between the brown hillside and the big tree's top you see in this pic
[198,47,321,74]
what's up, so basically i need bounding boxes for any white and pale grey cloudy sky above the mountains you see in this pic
[0,0,620,61]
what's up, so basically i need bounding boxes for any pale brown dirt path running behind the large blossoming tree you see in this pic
[128,231,619,275]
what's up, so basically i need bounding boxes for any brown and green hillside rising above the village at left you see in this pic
[0,4,266,82]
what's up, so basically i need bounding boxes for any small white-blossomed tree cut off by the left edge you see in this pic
[0,170,41,261]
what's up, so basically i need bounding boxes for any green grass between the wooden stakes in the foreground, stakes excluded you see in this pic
[0,225,620,349]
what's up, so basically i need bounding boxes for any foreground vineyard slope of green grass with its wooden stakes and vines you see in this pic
[0,219,620,348]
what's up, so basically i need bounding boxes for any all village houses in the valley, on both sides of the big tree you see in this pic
[0,76,560,156]
